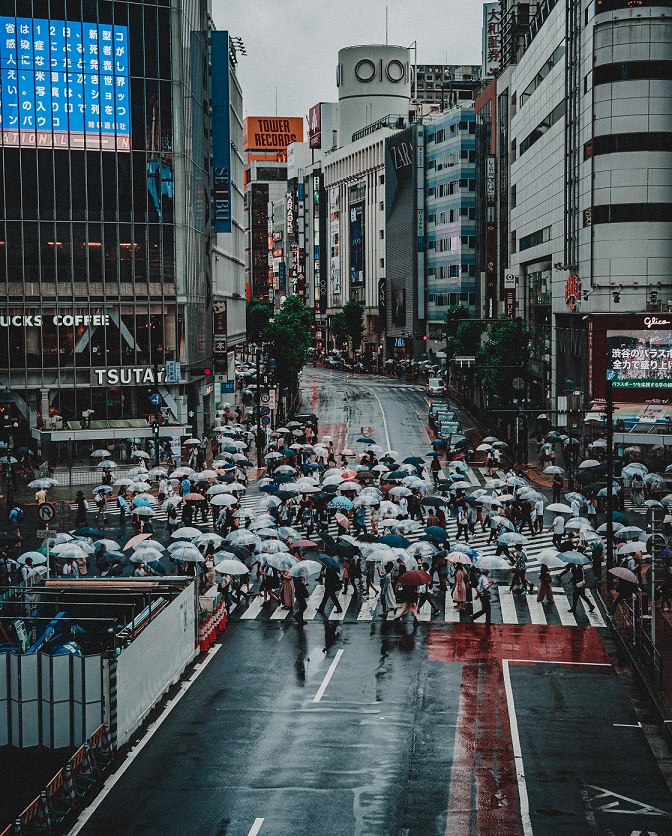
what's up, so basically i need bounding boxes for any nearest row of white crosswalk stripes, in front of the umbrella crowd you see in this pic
[229,583,607,627]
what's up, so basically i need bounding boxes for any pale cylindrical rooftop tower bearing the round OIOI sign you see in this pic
[336,44,413,141]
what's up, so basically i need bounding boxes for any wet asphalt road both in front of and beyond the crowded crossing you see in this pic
[73,369,672,836]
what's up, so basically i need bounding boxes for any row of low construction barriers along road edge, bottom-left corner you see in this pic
[0,725,114,836]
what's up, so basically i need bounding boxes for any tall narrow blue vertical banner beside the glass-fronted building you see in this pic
[210,32,231,232]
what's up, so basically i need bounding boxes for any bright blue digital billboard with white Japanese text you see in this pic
[0,17,131,151]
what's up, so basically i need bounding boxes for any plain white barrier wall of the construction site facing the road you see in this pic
[115,583,199,746]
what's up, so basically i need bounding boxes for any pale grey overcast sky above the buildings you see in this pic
[212,0,483,123]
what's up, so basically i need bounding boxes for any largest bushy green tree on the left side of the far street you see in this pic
[263,296,313,389]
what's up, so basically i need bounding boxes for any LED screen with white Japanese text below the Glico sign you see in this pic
[607,326,672,389]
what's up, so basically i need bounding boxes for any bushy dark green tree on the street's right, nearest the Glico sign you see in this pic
[476,317,530,406]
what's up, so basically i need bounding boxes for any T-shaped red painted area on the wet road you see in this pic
[427,624,609,836]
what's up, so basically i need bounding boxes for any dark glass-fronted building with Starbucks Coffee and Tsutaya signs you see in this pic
[0,0,212,458]
